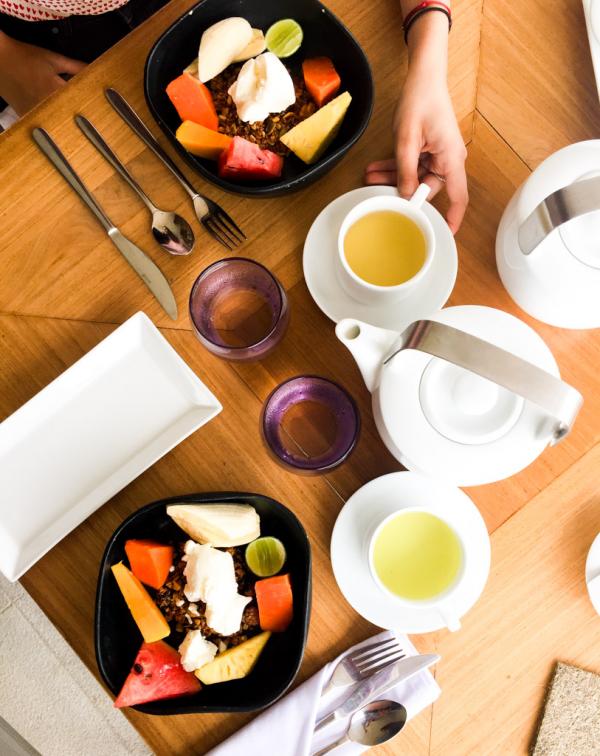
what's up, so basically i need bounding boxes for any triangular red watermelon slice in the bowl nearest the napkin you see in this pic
[114,641,202,709]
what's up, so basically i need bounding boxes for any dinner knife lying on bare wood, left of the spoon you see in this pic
[32,127,177,320]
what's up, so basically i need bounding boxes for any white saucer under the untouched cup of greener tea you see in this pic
[331,472,490,633]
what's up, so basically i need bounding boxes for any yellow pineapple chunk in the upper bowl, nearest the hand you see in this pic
[281,92,352,164]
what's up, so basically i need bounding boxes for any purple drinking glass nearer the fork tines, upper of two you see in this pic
[190,257,290,360]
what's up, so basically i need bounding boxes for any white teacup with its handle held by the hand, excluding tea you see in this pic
[336,184,435,305]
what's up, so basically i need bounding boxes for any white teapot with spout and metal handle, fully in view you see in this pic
[336,305,582,486]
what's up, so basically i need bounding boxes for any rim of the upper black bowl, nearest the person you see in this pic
[143,0,375,197]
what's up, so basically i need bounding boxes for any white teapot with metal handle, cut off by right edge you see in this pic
[496,139,600,328]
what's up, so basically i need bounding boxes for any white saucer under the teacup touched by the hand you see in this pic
[303,186,458,330]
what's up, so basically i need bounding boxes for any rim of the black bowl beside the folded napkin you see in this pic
[94,491,312,716]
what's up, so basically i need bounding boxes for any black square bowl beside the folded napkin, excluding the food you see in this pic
[94,493,311,714]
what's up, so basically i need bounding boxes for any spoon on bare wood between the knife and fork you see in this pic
[75,115,194,255]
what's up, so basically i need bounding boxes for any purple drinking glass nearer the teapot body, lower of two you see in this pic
[261,375,360,473]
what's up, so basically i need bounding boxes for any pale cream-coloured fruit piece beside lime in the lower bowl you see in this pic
[167,504,260,546]
